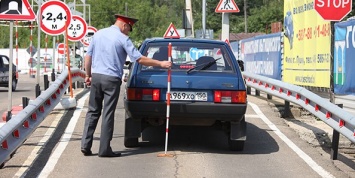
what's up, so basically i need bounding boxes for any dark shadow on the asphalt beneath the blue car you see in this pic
[123,123,279,156]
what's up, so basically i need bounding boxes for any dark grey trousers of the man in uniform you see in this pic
[81,74,122,155]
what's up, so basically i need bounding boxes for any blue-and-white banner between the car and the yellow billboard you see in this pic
[240,33,281,80]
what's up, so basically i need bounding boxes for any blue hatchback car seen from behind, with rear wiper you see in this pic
[124,38,247,151]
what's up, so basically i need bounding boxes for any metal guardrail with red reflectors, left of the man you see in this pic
[0,68,85,166]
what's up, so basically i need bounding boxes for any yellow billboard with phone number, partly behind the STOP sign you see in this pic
[282,0,331,88]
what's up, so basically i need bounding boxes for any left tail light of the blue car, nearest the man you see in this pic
[127,88,160,101]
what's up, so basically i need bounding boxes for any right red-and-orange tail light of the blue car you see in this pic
[214,90,247,103]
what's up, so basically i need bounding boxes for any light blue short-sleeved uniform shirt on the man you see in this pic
[86,25,142,78]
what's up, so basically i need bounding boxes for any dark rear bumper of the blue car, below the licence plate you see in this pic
[124,100,247,122]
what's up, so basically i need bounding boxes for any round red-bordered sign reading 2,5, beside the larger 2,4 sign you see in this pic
[68,15,88,41]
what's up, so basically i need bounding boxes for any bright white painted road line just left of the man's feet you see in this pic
[38,92,90,178]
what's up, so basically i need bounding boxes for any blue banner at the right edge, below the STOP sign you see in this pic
[333,20,355,95]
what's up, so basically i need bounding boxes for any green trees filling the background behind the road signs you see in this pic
[0,0,288,48]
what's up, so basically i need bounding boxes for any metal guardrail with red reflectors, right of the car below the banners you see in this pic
[243,72,355,143]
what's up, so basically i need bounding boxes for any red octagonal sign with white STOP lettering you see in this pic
[314,0,352,21]
